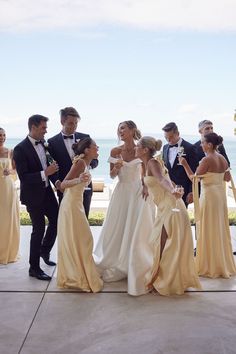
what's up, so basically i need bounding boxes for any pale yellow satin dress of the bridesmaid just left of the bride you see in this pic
[57,183,103,292]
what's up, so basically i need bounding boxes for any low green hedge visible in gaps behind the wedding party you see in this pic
[20,211,236,226]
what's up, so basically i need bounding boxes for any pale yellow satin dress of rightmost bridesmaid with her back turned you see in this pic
[193,172,236,278]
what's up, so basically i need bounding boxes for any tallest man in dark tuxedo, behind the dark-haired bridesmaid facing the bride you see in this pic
[48,107,98,218]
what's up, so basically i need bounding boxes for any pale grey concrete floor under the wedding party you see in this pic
[0,226,236,354]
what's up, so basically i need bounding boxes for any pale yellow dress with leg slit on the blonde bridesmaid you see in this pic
[144,167,201,295]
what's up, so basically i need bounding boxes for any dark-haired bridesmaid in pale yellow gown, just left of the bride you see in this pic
[57,138,103,292]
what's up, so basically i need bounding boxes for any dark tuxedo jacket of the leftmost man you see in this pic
[13,137,58,207]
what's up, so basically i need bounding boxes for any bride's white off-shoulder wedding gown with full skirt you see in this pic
[94,159,155,295]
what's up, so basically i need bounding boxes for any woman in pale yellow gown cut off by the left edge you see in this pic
[0,128,20,264]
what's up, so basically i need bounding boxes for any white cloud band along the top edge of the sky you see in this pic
[0,0,236,31]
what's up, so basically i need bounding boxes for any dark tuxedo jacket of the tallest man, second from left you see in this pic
[48,132,98,181]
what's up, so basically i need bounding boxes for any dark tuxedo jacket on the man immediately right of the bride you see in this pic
[163,139,197,204]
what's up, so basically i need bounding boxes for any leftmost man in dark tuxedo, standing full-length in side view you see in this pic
[13,114,58,280]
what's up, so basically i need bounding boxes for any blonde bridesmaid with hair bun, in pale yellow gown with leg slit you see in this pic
[136,137,201,295]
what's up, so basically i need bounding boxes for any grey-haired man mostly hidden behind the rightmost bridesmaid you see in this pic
[194,119,230,166]
